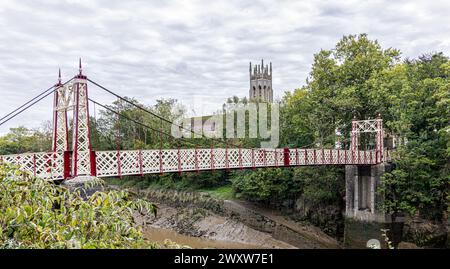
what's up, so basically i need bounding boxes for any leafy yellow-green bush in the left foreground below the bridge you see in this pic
[0,164,156,248]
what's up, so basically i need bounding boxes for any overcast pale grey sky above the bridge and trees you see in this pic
[0,0,450,134]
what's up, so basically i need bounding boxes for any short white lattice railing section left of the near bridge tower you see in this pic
[0,152,64,180]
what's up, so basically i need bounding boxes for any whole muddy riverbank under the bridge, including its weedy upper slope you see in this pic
[121,185,340,248]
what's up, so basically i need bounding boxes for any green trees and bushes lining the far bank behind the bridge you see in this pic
[0,34,450,247]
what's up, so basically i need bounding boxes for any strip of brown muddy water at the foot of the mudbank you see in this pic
[143,226,262,249]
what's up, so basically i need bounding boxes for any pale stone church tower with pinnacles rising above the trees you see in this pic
[249,60,273,103]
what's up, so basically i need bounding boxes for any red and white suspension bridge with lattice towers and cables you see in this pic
[0,60,388,180]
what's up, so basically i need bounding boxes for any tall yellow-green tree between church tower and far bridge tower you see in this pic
[306,34,400,147]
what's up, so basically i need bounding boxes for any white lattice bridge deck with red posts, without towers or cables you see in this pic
[0,148,384,180]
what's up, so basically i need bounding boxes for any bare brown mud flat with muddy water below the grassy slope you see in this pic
[137,205,295,249]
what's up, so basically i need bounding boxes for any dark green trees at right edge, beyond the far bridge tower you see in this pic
[380,53,450,220]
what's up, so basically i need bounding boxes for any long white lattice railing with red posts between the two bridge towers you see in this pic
[96,148,380,177]
